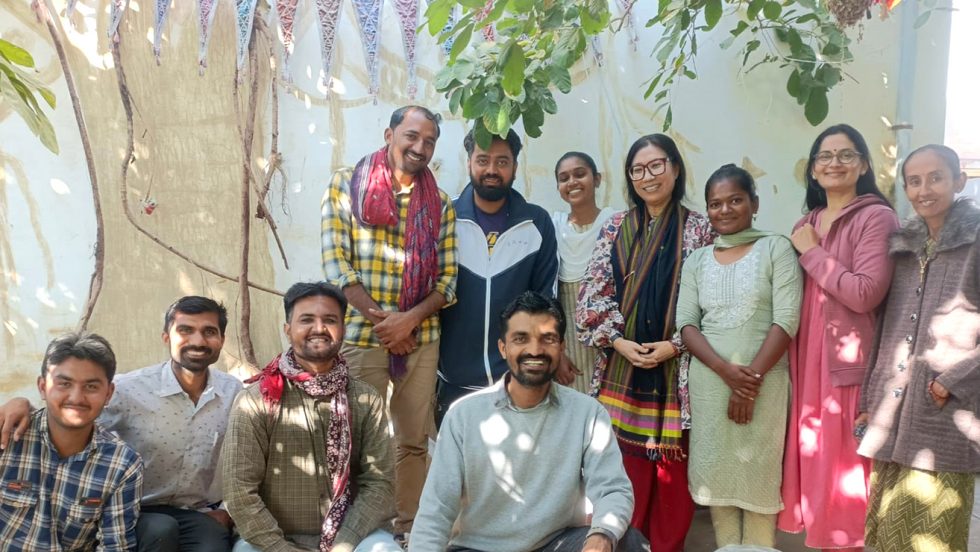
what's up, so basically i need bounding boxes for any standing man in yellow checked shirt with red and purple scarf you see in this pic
[321,106,457,541]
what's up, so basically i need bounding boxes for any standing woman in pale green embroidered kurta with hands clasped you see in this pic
[677,165,803,548]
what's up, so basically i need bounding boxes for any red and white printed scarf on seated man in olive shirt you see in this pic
[245,348,353,552]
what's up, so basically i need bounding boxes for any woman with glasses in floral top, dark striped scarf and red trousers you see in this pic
[575,134,714,552]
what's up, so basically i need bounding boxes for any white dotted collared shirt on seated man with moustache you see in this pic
[98,360,242,509]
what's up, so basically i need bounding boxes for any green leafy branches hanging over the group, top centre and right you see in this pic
[425,0,872,138]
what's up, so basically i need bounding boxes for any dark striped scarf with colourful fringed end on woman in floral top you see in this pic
[599,203,689,460]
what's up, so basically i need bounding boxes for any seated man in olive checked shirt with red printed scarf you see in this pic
[221,282,401,552]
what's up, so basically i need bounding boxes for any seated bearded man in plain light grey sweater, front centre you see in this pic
[409,291,650,552]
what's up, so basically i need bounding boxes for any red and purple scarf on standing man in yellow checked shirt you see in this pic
[350,146,442,379]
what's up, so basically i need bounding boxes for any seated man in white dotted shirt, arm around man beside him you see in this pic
[0,295,242,552]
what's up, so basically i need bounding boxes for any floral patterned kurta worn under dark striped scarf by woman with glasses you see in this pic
[575,211,715,429]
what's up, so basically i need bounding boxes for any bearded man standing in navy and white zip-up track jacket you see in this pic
[436,130,558,423]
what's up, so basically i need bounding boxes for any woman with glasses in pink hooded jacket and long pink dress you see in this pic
[778,124,898,550]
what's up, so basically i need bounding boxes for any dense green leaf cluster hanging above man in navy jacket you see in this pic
[423,0,610,148]
